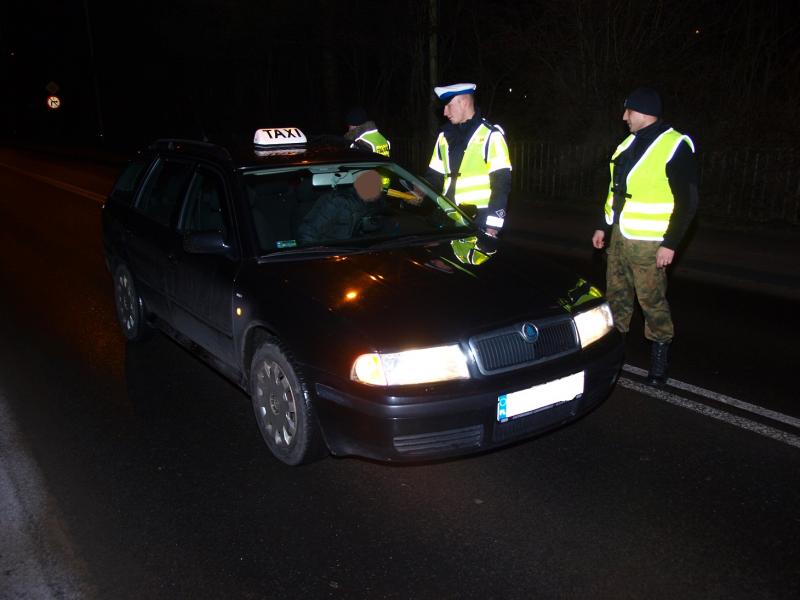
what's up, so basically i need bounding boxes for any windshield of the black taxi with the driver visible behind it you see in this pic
[243,162,474,255]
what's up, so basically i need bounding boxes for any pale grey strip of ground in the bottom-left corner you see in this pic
[0,392,91,600]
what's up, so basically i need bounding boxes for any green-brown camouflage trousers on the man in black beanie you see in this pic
[606,225,674,342]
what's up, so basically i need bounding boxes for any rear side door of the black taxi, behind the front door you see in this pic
[125,158,194,320]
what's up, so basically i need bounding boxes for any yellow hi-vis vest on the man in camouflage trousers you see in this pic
[605,127,694,242]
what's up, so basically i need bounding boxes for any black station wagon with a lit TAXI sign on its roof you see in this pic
[102,128,623,465]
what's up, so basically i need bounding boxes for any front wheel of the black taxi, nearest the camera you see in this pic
[250,343,327,466]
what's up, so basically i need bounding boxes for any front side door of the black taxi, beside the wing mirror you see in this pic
[169,164,239,365]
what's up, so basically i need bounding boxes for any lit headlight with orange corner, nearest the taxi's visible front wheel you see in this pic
[350,345,469,385]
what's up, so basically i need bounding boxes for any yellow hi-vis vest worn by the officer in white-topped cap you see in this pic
[429,121,511,208]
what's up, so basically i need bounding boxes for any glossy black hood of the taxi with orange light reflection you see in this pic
[250,239,582,350]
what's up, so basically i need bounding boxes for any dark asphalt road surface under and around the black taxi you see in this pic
[0,153,800,599]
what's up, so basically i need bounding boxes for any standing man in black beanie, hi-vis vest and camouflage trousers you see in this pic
[592,87,697,386]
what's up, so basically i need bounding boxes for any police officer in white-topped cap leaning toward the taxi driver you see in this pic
[427,83,511,237]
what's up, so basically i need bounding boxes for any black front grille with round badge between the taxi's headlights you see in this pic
[469,317,579,375]
